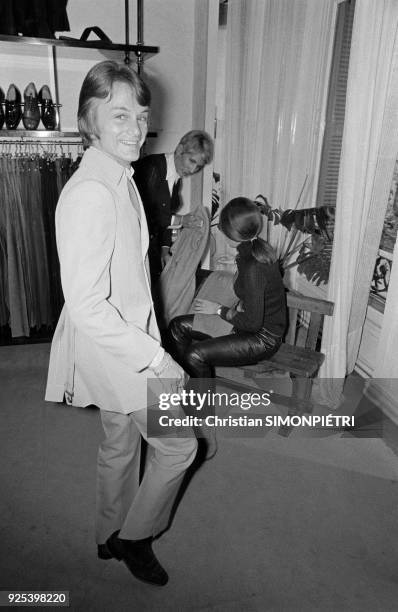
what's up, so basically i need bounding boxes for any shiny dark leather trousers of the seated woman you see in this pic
[169,315,281,378]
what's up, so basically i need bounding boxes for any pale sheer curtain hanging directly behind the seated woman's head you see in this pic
[224,0,335,238]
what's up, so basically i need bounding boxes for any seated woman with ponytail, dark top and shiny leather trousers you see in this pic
[169,197,286,378]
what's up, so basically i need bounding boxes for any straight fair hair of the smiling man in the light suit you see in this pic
[77,60,151,146]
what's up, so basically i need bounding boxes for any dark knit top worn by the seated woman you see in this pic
[221,242,287,336]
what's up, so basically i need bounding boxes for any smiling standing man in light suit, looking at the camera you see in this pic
[46,61,197,585]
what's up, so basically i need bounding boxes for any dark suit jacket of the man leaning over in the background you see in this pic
[133,153,182,280]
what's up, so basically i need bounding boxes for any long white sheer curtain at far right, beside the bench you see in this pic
[321,0,398,404]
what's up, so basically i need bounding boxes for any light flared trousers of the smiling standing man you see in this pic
[96,409,197,544]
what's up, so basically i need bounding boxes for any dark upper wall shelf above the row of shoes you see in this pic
[0,34,159,59]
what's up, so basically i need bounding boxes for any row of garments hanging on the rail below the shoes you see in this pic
[0,148,76,338]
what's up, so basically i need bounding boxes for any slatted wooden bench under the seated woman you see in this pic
[217,290,334,424]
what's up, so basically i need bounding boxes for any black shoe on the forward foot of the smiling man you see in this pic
[106,531,169,586]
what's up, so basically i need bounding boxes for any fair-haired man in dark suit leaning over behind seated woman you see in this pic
[133,130,214,282]
